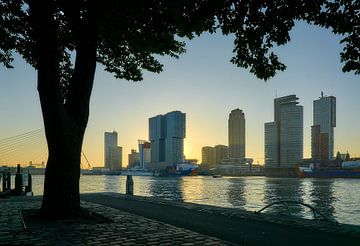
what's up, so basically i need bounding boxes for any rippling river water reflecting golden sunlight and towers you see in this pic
[28,175,360,225]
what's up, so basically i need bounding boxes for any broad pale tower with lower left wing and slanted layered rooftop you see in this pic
[265,95,303,168]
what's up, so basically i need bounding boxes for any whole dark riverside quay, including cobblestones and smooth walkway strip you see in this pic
[0,193,360,245]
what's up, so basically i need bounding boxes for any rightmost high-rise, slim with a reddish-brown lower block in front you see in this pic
[311,92,336,160]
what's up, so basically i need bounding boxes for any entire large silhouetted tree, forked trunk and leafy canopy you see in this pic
[0,0,360,215]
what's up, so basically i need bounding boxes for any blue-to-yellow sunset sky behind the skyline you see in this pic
[0,23,360,166]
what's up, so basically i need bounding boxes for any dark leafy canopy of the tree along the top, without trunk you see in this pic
[0,0,360,91]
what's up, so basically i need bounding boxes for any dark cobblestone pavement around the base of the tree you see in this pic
[0,197,234,246]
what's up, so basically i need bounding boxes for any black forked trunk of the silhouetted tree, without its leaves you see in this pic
[30,0,96,216]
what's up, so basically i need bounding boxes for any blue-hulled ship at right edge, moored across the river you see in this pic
[297,160,360,178]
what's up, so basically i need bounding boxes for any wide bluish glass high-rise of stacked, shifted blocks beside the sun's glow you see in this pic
[149,111,186,164]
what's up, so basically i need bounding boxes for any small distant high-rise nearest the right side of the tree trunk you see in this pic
[104,131,122,171]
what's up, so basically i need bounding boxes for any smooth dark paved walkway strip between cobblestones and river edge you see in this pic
[81,193,360,246]
